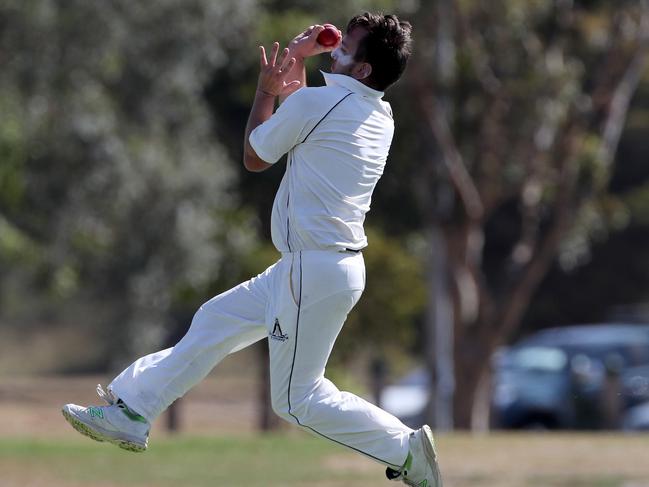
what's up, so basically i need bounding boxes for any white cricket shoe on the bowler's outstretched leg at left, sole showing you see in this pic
[61,385,151,452]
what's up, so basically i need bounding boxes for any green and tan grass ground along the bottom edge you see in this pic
[0,431,649,487]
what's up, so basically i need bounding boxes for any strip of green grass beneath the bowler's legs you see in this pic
[0,436,383,487]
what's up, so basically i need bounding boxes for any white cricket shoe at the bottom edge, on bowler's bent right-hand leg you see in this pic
[385,425,442,487]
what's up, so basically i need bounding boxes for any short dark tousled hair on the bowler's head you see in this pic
[347,12,412,91]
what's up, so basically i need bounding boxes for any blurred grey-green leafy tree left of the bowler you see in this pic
[0,0,255,364]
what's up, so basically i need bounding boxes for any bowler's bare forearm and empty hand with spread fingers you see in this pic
[243,42,300,172]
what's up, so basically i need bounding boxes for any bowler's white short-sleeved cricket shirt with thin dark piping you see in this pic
[250,73,394,252]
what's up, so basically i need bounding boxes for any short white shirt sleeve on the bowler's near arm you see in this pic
[249,88,310,164]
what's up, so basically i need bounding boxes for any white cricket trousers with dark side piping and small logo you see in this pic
[109,250,412,469]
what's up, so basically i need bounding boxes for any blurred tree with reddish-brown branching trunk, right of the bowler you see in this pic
[407,0,649,428]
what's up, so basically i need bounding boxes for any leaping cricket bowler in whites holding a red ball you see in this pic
[63,13,442,487]
